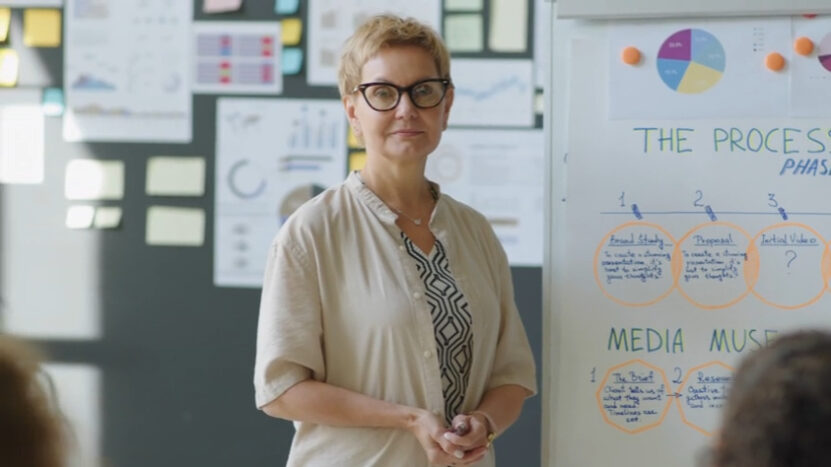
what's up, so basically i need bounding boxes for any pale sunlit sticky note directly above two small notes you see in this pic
[64,159,124,199]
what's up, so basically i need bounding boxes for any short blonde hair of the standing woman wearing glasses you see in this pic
[338,14,450,97]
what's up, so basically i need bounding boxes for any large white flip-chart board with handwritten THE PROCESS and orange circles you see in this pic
[543,8,831,467]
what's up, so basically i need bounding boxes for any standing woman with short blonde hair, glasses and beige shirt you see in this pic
[255,15,536,466]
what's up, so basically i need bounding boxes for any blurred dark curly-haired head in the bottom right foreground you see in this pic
[711,331,831,467]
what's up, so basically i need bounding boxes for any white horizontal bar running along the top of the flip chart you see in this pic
[557,0,831,18]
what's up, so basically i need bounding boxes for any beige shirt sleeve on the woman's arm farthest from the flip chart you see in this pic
[254,239,325,408]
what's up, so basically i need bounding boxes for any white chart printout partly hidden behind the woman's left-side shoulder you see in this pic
[214,98,346,287]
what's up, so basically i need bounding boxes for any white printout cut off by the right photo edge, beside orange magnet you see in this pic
[790,16,831,117]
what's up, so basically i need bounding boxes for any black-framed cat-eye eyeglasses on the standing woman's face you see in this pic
[352,78,450,112]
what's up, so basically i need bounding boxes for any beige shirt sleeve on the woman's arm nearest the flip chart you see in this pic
[488,235,537,396]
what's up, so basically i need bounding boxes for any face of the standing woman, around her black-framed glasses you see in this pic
[343,46,453,168]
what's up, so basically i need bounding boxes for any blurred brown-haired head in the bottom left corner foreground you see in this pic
[0,334,64,467]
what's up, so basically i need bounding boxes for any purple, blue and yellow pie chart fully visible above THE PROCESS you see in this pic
[658,29,724,94]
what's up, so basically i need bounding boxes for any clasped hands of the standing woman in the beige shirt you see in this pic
[413,411,490,465]
